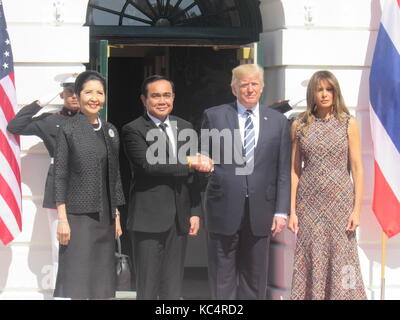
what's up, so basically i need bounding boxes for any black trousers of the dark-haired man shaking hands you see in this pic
[131,223,187,300]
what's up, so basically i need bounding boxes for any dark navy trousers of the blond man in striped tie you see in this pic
[208,201,270,300]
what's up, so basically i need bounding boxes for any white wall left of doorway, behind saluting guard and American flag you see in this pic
[0,0,89,299]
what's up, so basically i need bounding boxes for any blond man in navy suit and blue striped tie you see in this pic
[201,65,290,299]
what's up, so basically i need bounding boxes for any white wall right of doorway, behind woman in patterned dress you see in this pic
[260,0,400,299]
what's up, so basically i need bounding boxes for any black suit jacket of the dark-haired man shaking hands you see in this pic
[122,114,200,233]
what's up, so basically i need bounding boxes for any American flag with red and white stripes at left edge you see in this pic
[0,1,22,245]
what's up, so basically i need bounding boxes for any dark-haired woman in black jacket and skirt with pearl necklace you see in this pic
[54,71,124,299]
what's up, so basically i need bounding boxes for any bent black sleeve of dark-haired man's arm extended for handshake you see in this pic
[122,126,192,177]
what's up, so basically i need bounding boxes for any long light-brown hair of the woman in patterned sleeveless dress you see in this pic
[299,70,350,134]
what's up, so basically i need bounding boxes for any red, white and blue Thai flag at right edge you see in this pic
[369,0,400,238]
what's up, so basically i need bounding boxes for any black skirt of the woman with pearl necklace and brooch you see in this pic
[54,213,116,299]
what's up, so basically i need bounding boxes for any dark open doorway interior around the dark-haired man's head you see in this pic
[108,47,239,128]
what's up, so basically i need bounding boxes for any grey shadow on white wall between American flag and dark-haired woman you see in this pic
[21,143,52,298]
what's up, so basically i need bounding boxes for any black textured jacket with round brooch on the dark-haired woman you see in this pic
[54,113,125,216]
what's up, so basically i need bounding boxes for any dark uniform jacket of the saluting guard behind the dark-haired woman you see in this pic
[7,102,74,209]
